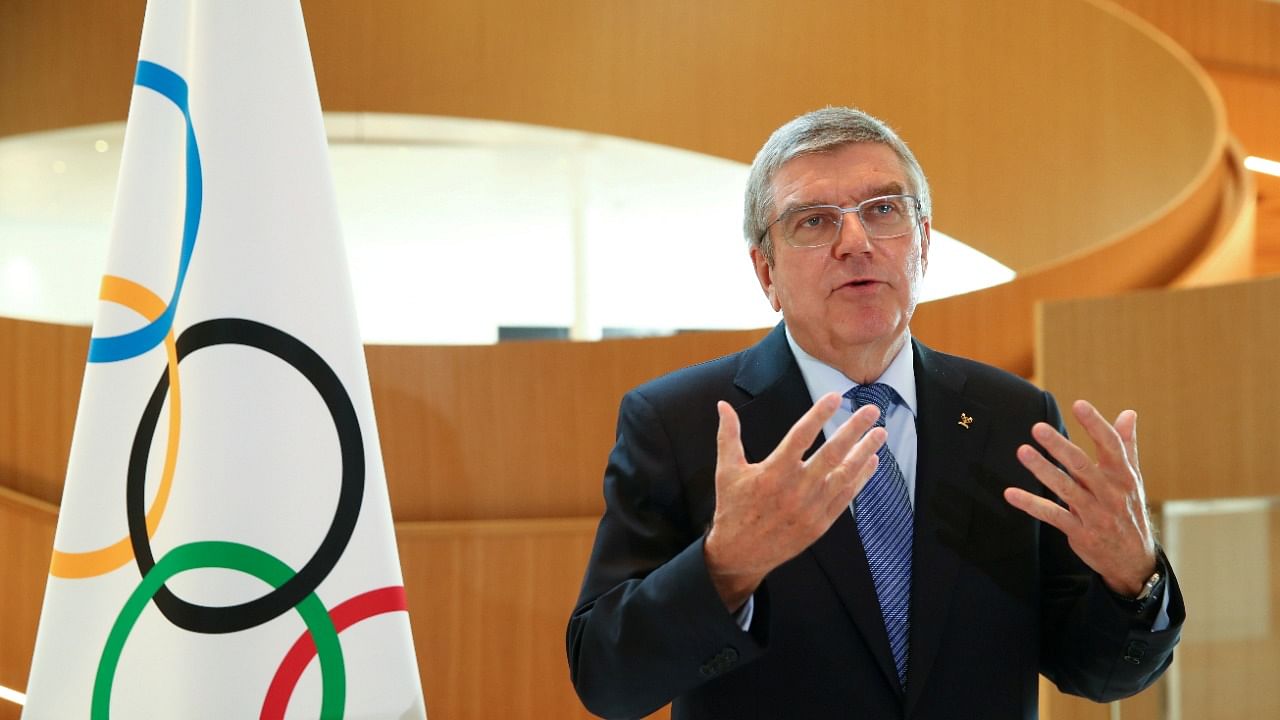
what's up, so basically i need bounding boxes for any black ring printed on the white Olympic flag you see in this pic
[124,318,365,633]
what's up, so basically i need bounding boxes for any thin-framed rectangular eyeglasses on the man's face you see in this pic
[760,195,920,247]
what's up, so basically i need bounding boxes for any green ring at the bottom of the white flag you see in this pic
[90,542,347,720]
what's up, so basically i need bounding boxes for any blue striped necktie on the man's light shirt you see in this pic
[845,383,911,688]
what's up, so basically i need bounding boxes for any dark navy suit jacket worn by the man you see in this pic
[567,325,1185,720]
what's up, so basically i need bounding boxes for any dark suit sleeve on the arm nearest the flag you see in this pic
[567,391,767,717]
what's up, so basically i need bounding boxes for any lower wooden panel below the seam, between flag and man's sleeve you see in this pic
[396,518,609,720]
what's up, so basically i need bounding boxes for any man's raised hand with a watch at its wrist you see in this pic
[1005,400,1157,597]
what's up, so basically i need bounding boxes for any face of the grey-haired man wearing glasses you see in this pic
[751,142,929,366]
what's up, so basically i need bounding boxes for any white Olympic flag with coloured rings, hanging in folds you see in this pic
[24,0,425,720]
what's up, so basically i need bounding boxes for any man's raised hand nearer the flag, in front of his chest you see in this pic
[703,393,886,612]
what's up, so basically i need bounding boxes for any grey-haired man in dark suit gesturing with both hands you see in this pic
[567,108,1185,720]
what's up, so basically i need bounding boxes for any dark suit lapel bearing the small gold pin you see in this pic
[905,342,995,717]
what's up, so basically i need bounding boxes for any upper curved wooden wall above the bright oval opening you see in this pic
[0,0,1224,270]
